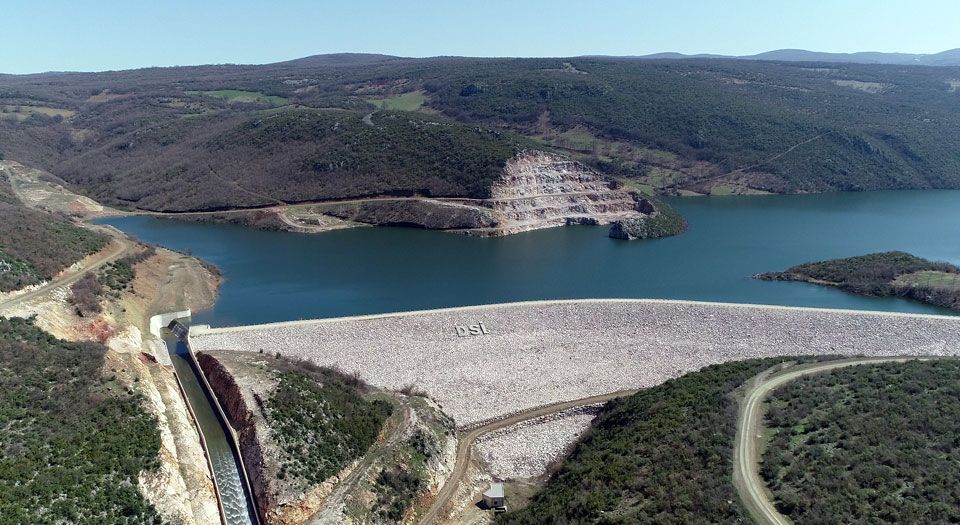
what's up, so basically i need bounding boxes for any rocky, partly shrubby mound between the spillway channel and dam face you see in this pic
[197,351,453,523]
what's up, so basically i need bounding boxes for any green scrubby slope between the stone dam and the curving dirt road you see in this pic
[498,359,776,524]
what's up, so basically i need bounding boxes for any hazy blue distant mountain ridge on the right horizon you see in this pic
[633,48,960,66]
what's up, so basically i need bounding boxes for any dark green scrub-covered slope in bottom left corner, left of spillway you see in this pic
[0,317,160,525]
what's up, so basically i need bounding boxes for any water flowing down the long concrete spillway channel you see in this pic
[166,336,255,525]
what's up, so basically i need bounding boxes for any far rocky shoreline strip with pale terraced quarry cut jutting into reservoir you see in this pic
[165,151,686,239]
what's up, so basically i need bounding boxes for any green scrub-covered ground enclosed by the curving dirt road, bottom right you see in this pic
[761,360,960,523]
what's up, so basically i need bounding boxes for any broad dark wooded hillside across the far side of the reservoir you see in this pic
[0,55,960,211]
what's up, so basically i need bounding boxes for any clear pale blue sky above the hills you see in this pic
[0,0,960,73]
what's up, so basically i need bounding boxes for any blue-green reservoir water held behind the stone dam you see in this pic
[102,191,960,326]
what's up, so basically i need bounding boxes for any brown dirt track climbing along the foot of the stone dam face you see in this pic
[420,390,638,525]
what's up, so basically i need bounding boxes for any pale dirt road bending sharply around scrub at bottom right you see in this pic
[733,357,927,525]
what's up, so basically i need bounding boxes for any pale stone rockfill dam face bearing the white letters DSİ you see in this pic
[192,300,960,428]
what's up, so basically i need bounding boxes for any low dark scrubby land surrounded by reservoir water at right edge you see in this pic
[754,251,960,309]
